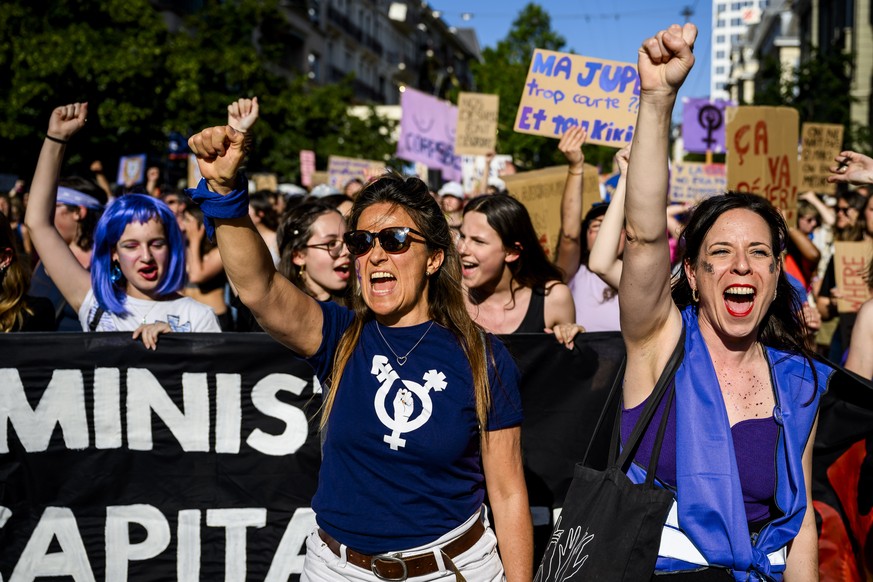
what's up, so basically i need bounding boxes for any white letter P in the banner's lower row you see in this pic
[106,504,170,580]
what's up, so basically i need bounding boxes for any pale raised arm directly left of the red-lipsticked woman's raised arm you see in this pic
[588,144,631,289]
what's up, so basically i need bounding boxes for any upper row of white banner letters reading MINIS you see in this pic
[0,368,309,456]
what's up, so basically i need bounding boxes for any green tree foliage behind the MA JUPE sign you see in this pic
[473,3,616,171]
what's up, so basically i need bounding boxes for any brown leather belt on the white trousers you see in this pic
[318,520,485,580]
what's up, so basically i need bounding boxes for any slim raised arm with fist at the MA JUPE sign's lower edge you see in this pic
[555,127,588,283]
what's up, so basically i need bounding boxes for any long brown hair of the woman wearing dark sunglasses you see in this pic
[321,173,493,434]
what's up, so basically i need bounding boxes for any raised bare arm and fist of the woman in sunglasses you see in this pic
[188,110,322,356]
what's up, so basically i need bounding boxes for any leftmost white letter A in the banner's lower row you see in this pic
[9,507,96,582]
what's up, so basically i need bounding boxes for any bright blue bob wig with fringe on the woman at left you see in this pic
[91,194,185,315]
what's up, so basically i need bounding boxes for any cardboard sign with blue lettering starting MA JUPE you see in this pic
[515,49,640,148]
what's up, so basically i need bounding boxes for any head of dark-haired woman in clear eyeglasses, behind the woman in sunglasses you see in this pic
[277,199,349,304]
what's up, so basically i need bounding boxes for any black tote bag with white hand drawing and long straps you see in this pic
[534,327,685,582]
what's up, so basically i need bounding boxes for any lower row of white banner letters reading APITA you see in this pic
[0,504,316,582]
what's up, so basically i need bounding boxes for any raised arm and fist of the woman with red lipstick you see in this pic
[618,24,697,406]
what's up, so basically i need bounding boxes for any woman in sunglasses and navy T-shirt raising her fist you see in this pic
[189,116,533,582]
